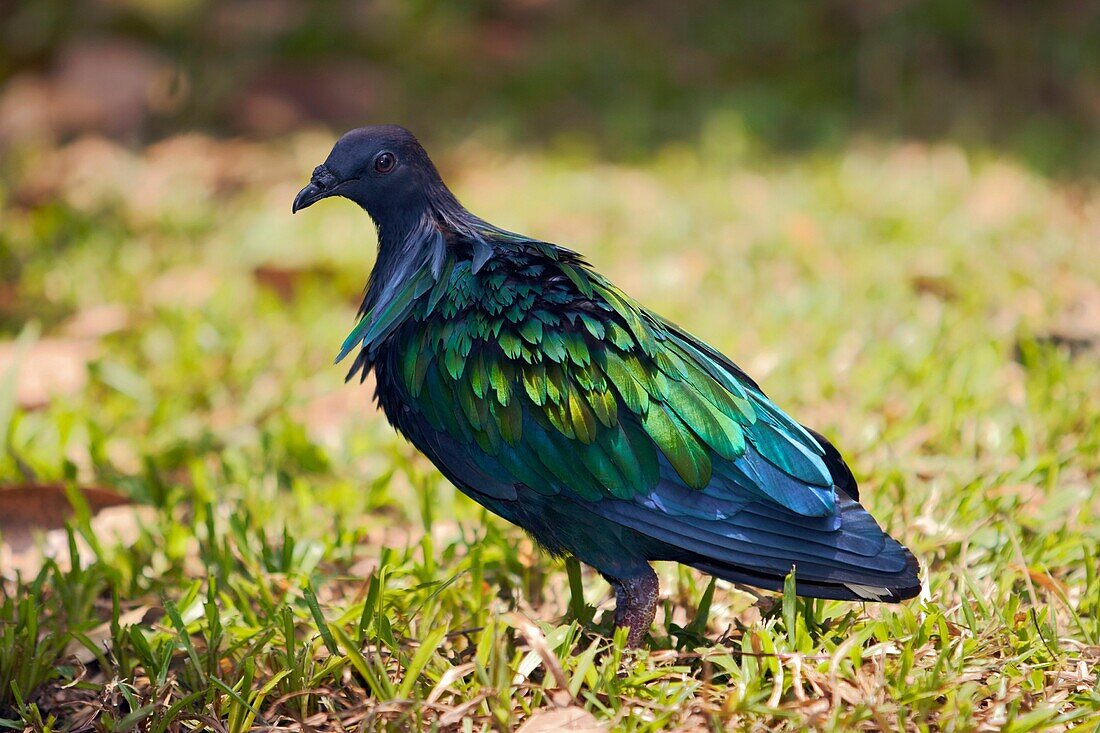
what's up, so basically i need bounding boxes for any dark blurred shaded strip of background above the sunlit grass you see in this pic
[0,0,1100,174]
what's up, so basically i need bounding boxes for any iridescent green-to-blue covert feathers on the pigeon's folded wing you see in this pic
[382,248,836,516]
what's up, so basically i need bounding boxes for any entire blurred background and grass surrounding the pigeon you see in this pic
[0,0,1100,733]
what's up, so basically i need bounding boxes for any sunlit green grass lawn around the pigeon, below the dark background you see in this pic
[0,131,1100,732]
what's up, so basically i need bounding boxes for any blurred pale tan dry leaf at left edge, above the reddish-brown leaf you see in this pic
[0,339,97,409]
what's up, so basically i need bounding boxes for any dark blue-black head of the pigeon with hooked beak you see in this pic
[292,124,453,228]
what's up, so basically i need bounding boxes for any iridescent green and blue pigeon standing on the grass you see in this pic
[292,124,921,647]
